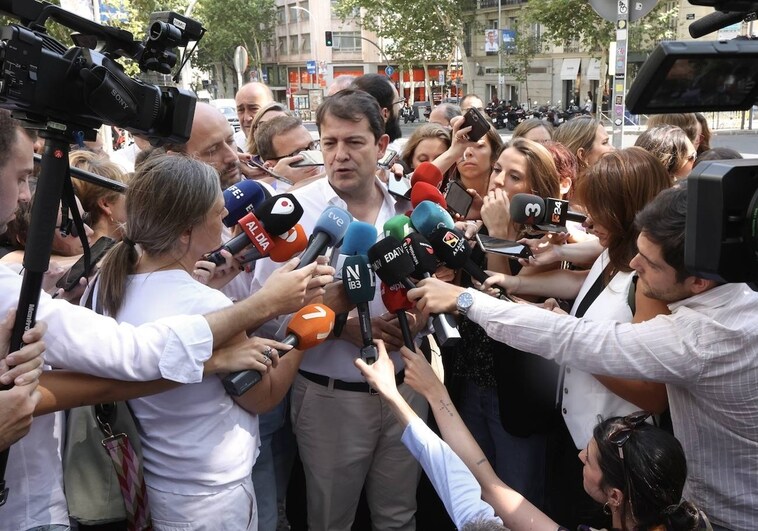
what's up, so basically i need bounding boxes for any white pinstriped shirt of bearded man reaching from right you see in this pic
[467,284,758,531]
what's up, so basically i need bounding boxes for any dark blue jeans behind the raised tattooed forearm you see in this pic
[459,381,547,508]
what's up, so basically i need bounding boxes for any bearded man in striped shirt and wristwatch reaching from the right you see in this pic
[408,185,758,531]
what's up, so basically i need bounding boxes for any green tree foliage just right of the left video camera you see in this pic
[193,0,276,72]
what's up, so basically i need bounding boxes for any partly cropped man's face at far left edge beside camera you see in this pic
[0,131,34,234]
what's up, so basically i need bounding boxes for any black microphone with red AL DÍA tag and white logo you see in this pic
[204,194,303,265]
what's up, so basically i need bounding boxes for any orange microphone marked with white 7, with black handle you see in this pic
[222,304,334,396]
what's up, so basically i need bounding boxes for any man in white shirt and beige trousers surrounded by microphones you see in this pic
[253,90,426,531]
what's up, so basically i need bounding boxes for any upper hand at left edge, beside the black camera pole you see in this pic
[0,310,47,387]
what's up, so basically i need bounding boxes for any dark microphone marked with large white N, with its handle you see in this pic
[342,254,378,364]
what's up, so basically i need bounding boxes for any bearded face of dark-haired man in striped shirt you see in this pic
[629,232,693,302]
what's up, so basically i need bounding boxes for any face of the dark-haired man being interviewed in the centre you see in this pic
[321,114,389,197]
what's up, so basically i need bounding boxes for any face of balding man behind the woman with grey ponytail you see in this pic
[186,104,240,188]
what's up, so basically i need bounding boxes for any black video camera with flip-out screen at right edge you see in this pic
[627,0,758,291]
